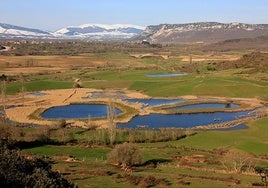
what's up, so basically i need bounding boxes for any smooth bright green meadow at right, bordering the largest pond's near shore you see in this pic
[140,118,268,155]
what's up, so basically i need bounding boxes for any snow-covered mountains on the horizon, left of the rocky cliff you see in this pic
[0,23,145,40]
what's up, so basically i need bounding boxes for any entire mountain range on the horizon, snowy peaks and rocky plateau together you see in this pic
[0,22,268,43]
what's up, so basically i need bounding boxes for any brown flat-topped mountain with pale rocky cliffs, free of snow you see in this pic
[133,22,268,43]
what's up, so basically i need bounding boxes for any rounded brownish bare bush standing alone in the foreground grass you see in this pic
[108,143,142,168]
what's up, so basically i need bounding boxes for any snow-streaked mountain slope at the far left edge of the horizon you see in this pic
[0,23,51,38]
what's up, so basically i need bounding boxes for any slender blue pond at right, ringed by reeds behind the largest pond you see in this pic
[167,103,239,110]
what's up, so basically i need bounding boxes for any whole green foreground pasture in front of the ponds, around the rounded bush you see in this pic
[24,118,268,187]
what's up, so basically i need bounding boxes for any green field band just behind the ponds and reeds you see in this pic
[7,70,268,98]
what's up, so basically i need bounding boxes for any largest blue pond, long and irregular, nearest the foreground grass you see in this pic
[118,111,249,128]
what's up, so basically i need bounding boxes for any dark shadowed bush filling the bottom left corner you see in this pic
[0,140,74,187]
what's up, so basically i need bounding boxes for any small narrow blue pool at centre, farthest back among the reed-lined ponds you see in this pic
[125,99,185,106]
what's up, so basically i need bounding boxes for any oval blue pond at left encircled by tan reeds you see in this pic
[41,104,121,119]
